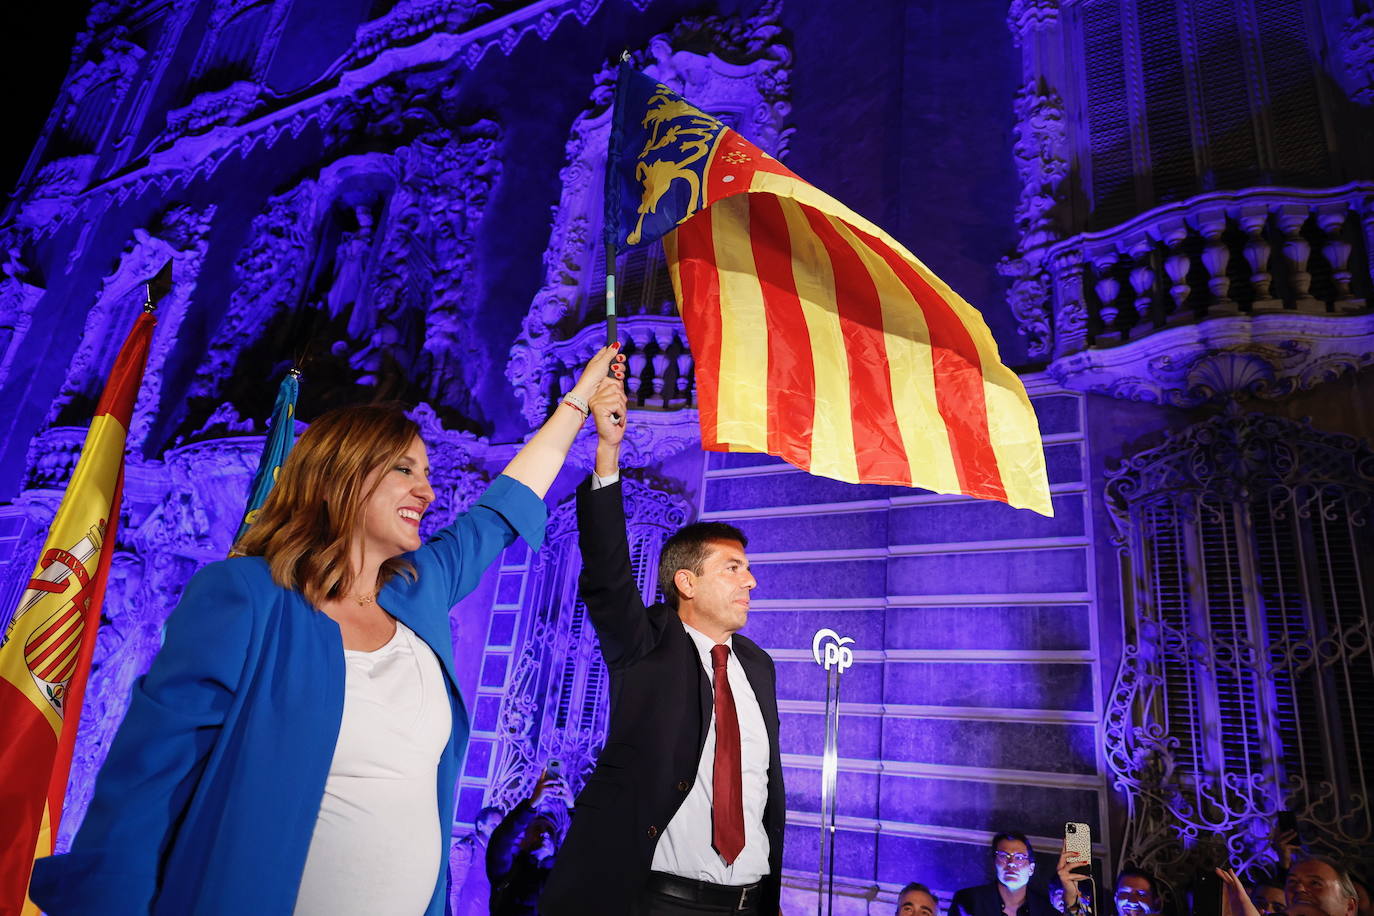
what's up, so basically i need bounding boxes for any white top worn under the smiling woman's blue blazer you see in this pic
[295,621,452,916]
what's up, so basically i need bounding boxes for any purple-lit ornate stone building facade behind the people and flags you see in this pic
[0,0,1374,913]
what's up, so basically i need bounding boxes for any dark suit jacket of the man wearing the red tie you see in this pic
[540,481,786,916]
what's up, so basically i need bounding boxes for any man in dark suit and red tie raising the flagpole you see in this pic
[540,385,786,916]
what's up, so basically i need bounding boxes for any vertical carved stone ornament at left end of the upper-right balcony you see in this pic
[998,80,1069,358]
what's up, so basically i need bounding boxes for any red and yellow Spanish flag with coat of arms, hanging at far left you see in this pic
[0,312,155,915]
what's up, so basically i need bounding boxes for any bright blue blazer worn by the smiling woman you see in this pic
[29,477,547,916]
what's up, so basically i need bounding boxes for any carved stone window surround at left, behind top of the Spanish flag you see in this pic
[30,205,214,467]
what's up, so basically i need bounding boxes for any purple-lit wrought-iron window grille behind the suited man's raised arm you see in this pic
[482,478,690,810]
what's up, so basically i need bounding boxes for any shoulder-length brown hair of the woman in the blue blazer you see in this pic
[234,404,419,606]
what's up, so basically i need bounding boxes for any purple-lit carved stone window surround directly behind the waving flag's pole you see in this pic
[506,3,791,426]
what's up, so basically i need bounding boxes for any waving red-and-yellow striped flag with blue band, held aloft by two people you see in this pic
[606,63,1052,515]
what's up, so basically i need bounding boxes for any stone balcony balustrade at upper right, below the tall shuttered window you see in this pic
[1046,183,1374,357]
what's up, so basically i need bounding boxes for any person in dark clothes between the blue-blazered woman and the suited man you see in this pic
[486,770,572,916]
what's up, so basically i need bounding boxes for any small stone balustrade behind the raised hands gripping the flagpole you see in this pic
[552,314,697,411]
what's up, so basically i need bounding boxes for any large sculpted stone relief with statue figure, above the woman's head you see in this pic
[180,112,500,439]
